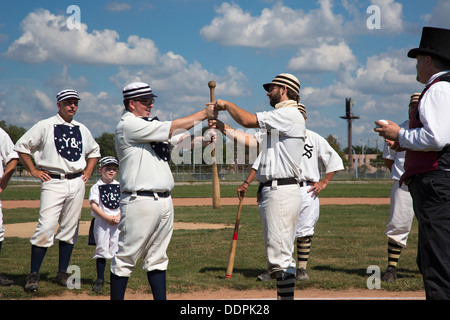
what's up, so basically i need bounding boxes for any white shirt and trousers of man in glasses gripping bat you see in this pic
[111,110,174,277]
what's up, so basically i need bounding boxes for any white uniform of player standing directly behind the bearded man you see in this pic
[295,130,344,238]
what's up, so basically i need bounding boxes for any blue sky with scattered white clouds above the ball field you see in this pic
[0,0,450,152]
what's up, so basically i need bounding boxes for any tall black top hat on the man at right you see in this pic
[408,27,450,60]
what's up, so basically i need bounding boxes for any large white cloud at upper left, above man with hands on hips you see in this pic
[6,9,159,65]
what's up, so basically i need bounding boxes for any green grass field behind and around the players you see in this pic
[0,183,423,299]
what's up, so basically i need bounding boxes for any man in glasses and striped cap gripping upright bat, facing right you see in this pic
[111,82,217,300]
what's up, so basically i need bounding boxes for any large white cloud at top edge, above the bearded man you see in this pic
[200,0,343,48]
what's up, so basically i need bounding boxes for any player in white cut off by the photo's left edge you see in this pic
[0,128,19,286]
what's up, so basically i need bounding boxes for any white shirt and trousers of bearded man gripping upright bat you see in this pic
[252,100,305,274]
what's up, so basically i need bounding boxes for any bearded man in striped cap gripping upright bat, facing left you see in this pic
[207,73,306,300]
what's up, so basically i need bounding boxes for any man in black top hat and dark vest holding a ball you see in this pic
[374,27,450,299]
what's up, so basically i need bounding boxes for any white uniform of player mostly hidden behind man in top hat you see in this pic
[383,120,414,248]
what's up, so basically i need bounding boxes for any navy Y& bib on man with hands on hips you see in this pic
[53,124,83,162]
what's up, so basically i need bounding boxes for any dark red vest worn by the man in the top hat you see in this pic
[400,73,450,183]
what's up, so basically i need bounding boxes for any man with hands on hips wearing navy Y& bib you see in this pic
[14,89,100,292]
